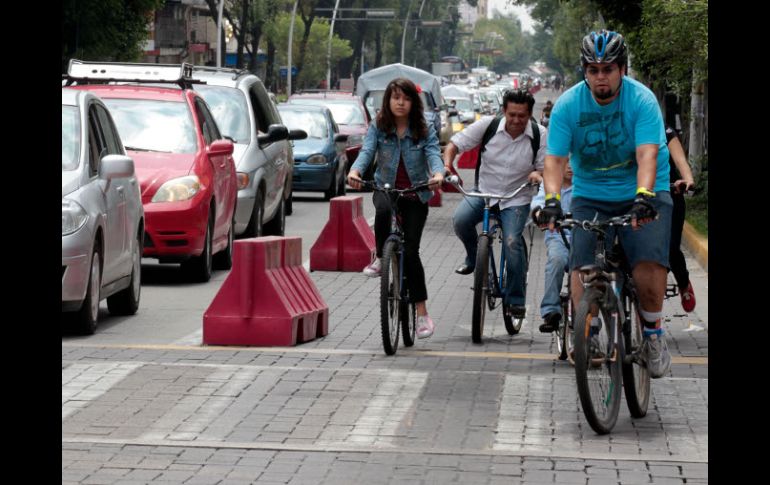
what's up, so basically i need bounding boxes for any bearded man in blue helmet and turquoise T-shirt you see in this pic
[538,30,672,378]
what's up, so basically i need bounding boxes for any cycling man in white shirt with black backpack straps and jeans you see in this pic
[444,89,547,318]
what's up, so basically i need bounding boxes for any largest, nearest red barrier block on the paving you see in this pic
[203,236,329,346]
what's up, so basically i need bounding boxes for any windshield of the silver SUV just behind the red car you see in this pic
[195,85,251,143]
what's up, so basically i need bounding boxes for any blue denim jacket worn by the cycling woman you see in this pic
[350,121,444,203]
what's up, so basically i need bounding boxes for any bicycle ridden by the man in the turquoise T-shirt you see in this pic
[557,215,650,434]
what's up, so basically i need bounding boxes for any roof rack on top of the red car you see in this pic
[62,59,205,89]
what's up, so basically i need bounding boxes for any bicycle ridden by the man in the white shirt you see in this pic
[447,176,539,344]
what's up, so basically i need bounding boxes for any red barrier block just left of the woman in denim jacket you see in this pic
[310,195,376,271]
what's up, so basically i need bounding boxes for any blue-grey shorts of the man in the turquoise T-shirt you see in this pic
[569,192,673,269]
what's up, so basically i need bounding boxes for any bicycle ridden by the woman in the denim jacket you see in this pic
[361,180,429,355]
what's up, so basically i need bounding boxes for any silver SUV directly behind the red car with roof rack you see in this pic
[193,66,296,237]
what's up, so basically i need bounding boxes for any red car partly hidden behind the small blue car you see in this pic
[288,91,371,175]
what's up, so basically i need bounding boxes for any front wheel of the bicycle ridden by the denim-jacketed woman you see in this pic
[380,240,401,355]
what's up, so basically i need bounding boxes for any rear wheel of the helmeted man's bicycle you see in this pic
[623,289,650,418]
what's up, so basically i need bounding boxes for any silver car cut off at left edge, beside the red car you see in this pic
[61,88,144,334]
